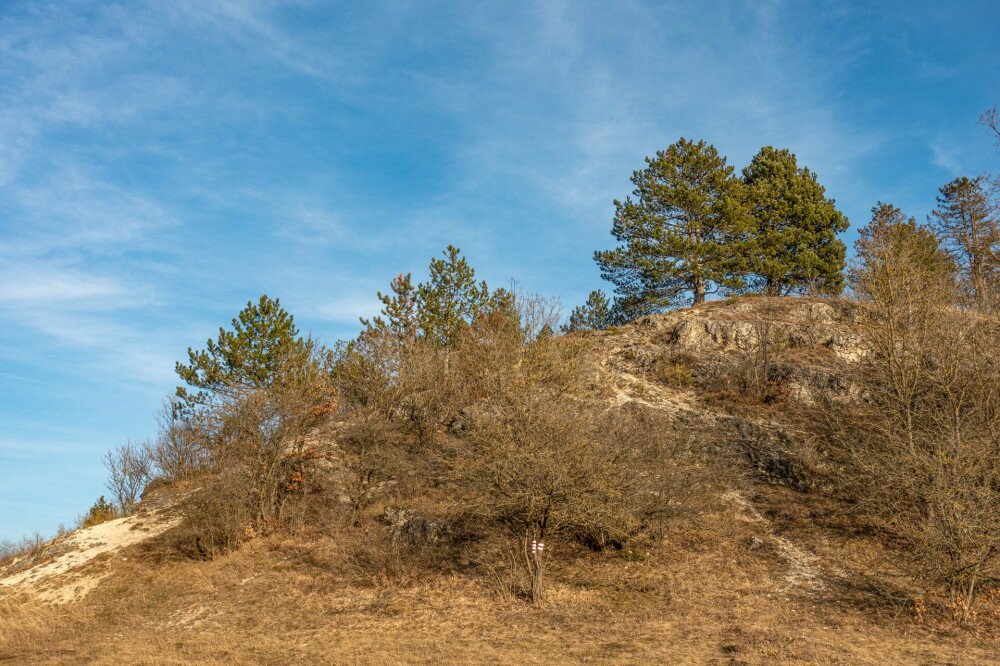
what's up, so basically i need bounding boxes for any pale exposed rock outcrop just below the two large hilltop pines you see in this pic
[587,298,861,490]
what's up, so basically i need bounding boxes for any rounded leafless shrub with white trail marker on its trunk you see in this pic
[450,317,697,600]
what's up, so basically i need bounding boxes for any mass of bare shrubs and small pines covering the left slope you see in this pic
[88,248,720,599]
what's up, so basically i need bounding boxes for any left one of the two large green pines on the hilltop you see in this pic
[594,138,751,313]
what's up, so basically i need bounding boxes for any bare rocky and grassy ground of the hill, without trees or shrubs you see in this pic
[0,298,1000,664]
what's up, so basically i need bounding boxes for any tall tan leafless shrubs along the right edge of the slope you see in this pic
[826,214,1000,621]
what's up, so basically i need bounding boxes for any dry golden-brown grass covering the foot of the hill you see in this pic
[0,491,1000,664]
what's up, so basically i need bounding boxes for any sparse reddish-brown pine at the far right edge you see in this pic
[931,177,1000,310]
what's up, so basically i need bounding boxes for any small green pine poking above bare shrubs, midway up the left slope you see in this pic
[416,245,494,347]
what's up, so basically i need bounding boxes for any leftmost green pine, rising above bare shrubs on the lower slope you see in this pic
[176,294,307,409]
